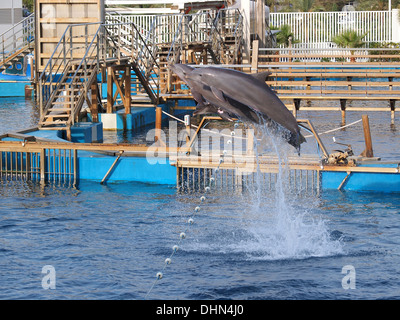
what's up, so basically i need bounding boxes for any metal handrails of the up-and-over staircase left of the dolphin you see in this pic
[39,18,159,117]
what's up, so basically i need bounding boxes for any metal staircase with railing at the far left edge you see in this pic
[0,14,35,72]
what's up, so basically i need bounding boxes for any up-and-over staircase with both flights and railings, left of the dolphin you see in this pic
[38,23,159,139]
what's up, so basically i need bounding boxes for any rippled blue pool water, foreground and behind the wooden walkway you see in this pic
[0,99,400,300]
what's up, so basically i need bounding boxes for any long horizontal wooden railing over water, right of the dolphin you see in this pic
[252,45,400,121]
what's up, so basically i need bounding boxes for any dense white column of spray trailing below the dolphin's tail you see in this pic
[235,126,343,260]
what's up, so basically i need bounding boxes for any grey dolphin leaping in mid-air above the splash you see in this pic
[171,64,305,151]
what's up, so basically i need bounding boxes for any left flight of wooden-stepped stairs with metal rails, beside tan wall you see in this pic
[38,23,103,138]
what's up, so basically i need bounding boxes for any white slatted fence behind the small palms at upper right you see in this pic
[270,10,399,48]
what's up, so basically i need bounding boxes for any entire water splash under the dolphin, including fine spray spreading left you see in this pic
[188,126,343,260]
